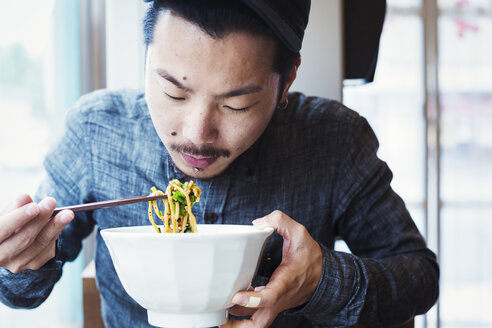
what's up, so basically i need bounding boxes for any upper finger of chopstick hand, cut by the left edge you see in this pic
[0,203,40,244]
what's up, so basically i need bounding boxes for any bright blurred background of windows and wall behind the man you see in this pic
[0,0,492,328]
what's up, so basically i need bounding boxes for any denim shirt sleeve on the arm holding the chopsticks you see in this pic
[0,103,94,308]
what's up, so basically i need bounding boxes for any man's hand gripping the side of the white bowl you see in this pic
[221,211,323,328]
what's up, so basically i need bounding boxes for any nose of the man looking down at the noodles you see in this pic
[183,106,218,145]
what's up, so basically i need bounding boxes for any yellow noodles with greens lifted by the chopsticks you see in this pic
[148,179,202,233]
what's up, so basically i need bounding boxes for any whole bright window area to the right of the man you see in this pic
[344,0,492,328]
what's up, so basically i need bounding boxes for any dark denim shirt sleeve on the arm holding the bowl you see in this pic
[288,117,439,327]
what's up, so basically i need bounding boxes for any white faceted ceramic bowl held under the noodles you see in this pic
[101,225,273,328]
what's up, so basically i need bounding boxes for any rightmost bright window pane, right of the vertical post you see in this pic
[438,0,492,327]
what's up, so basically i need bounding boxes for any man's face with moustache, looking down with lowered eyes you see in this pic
[145,13,280,178]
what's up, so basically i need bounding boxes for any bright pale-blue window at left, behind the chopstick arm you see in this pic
[0,0,82,328]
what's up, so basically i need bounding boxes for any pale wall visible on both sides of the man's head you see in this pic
[106,0,343,100]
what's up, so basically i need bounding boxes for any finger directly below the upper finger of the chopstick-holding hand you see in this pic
[0,197,56,263]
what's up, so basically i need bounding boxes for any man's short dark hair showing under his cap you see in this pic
[143,0,299,93]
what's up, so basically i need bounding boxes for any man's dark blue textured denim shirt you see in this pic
[0,90,439,328]
